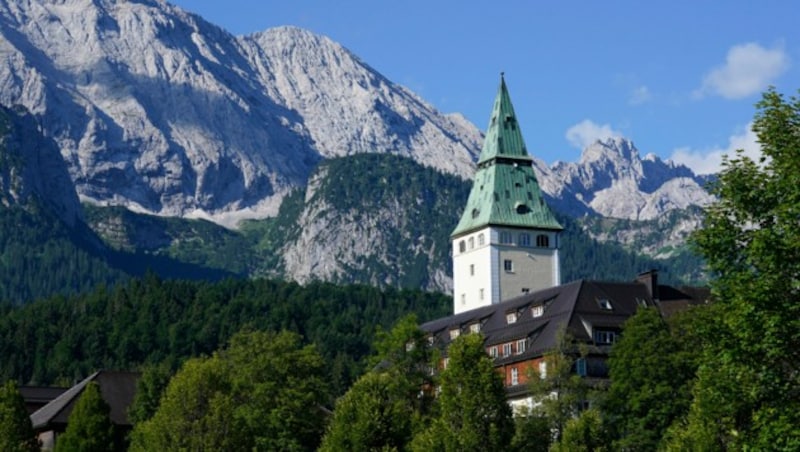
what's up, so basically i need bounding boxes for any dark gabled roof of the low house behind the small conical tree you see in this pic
[31,370,139,430]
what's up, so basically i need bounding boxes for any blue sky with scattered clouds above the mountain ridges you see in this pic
[172,0,800,173]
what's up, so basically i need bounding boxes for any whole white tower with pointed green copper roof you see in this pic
[451,74,563,314]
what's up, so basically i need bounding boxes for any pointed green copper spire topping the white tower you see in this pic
[452,74,563,237]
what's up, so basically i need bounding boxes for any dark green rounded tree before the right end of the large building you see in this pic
[603,306,708,450]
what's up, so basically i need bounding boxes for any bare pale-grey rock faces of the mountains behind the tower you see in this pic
[0,0,710,287]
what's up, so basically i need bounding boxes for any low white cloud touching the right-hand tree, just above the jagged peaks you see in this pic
[670,123,761,174]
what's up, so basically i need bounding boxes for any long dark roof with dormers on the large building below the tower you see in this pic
[421,280,653,364]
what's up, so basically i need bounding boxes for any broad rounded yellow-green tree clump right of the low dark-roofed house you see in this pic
[131,331,328,451]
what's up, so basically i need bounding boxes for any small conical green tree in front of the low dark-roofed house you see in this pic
[55,381,115,452]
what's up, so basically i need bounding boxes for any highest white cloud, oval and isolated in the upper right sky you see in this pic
[694,42,789,99]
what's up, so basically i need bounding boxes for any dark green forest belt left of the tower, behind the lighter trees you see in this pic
[0,274,452,395]
